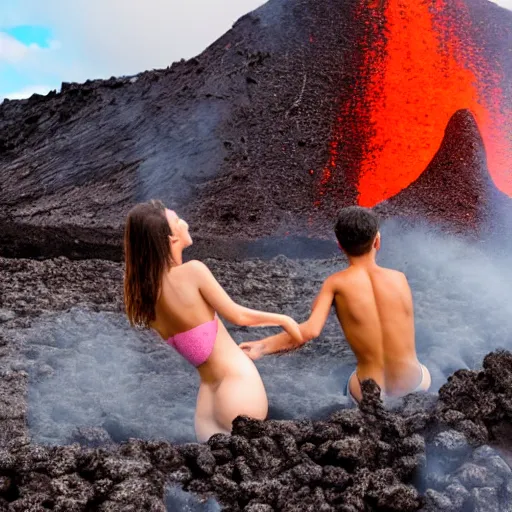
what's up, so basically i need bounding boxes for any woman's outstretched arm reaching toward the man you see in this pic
[192,260,302,342]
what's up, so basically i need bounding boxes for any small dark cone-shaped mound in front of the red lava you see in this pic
[376,110,512,232]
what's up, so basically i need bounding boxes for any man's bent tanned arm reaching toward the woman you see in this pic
[240,276,336,359]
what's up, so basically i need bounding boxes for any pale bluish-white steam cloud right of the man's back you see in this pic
[379,221,512,390]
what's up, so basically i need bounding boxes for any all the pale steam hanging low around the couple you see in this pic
[25,218,512,444]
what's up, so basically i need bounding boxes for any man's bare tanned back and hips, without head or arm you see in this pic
[334,265,426,400]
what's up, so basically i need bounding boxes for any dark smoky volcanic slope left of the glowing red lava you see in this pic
[0,0,512,259]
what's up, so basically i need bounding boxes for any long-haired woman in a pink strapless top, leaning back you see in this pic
[124,201,302,442]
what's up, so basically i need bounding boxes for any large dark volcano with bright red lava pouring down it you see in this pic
[0,0,512,260]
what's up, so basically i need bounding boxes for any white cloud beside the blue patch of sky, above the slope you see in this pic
[2,0,265,81]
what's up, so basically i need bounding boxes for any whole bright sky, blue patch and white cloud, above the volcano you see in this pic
[0,0,512,101]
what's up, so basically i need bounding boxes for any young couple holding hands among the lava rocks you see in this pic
[124,201,430,442]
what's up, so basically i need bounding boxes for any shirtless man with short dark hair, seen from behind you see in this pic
[240,206,431,402]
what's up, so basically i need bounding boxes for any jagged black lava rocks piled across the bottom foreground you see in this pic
[0,351,512,512]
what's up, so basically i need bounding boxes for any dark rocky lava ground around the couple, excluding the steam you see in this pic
[0,254,512,512]
